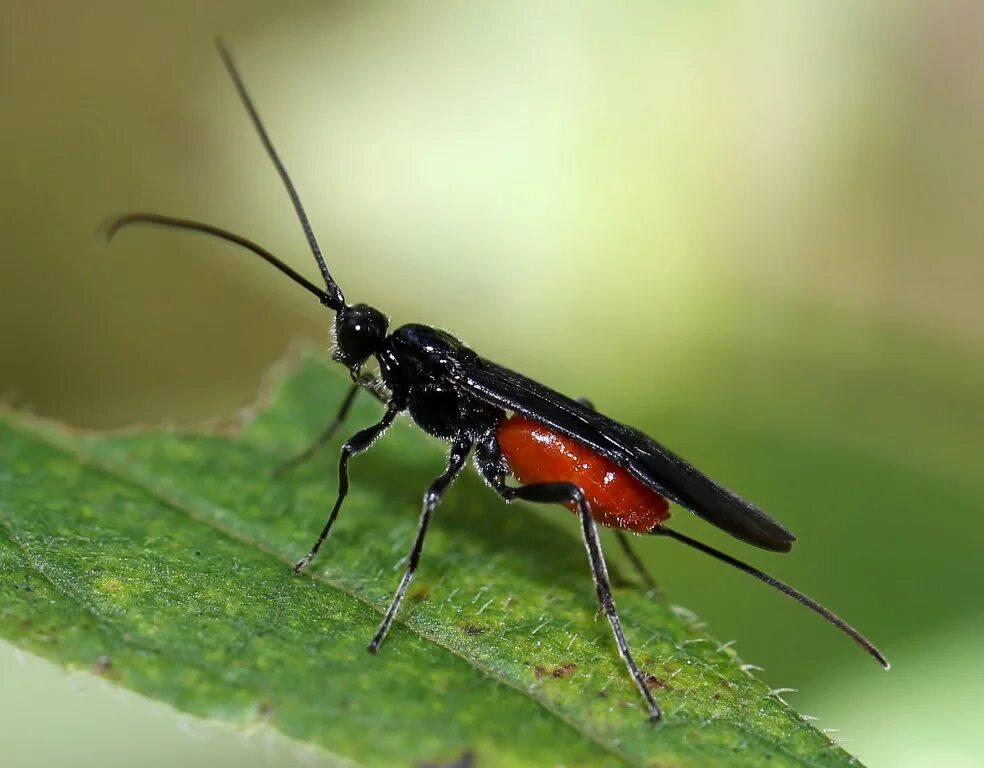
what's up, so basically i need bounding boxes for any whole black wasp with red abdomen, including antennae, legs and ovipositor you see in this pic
[109,43,888,720]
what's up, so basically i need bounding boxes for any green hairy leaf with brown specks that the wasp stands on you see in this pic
[0,358,856,768]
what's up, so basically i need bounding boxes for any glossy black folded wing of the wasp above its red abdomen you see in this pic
[457,356,796,552]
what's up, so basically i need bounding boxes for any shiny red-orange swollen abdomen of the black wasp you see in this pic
[498,416,670,533]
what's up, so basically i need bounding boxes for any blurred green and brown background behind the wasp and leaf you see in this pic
[0,0,984,766]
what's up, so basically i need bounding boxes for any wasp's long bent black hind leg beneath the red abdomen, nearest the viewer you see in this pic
[475,438,662,722]
